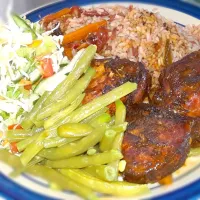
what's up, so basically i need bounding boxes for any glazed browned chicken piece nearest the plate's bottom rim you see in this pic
[122,104,190,183]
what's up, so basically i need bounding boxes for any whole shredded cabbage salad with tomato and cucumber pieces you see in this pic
[0,14,71,132]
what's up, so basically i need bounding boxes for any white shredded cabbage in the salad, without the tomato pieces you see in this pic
[0,18,69,131]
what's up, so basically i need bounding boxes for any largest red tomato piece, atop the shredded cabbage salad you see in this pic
[41,58,54,78]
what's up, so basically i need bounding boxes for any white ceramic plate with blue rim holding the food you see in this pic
[0,0,200,200]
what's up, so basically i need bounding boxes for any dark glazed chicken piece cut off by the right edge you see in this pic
[153,50,200,147]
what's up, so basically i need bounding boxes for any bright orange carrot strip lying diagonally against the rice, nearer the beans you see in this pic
[63,20,107,45]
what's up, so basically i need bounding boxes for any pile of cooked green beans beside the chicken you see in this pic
[0,45,148,200]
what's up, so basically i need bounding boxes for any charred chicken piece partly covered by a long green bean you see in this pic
[83,58,151,110]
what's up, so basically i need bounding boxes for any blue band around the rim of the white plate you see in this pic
[0,0,200,200]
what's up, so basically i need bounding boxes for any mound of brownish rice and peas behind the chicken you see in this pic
[47,6,200,76]
